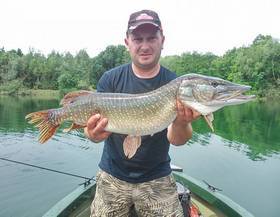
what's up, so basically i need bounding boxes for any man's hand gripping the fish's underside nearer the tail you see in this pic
[84,114,111,143]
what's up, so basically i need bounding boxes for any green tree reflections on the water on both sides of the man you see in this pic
[0,96,280,160]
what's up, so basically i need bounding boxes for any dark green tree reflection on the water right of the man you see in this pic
[193,102,280,160]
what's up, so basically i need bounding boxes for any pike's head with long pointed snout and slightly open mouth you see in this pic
[178,74,255,115]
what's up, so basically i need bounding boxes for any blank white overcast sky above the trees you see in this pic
[0,0,280,57]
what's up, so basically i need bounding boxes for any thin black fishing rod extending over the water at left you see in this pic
[0,157,95,187]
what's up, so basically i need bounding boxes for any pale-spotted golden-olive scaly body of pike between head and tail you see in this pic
[57,80,177,135]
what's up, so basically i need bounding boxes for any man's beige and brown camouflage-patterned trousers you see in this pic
[91,170,183,217]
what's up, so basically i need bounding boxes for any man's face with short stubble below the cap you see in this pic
[125,24,164,69]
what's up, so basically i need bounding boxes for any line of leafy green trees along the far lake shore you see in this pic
[0,35,280,97]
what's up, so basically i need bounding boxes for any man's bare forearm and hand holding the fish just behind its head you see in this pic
[167,100,201,146]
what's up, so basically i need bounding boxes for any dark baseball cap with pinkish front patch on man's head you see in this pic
[127,10,162,32]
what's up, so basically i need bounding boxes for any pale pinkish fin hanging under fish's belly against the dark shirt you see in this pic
[123,135,141,159]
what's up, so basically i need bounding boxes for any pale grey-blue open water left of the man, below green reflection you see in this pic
[0,130,102,217]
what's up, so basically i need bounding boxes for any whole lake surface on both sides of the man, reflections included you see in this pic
[0,96,280,217]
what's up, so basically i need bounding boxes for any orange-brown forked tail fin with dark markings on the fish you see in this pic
[25,110,60,143]
